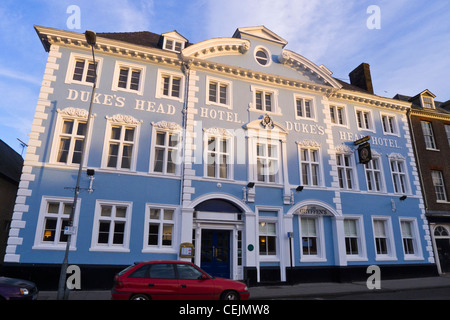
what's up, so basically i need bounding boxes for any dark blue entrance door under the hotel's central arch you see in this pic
[200,230,230,278]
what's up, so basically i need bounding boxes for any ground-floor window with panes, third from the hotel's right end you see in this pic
[344,217,366,260]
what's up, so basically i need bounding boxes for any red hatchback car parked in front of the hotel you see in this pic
[111,261,250,300]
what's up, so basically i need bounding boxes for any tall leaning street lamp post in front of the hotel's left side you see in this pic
[57,30,97,300]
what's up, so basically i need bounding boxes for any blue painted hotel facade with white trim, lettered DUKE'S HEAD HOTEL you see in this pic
[5,27,434,282]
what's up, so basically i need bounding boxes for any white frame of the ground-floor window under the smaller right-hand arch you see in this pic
[298,215,327,262]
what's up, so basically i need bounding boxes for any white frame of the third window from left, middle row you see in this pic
[149,123,183,176]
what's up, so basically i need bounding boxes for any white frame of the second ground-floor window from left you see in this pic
[89,200,133,252]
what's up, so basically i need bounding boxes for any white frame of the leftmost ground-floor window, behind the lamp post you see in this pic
[32,196,81,251]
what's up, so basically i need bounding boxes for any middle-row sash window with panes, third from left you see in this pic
[152,130,180,174]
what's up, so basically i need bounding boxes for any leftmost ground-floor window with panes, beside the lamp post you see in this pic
[33,196,81,250]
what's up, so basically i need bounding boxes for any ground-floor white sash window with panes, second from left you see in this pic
[91,201,131,252]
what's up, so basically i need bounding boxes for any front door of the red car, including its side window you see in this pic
[177,263,219,300]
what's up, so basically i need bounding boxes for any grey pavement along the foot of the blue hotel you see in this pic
[38,275,450,300]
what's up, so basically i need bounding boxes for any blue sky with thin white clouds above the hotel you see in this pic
[0,0,450,156]
